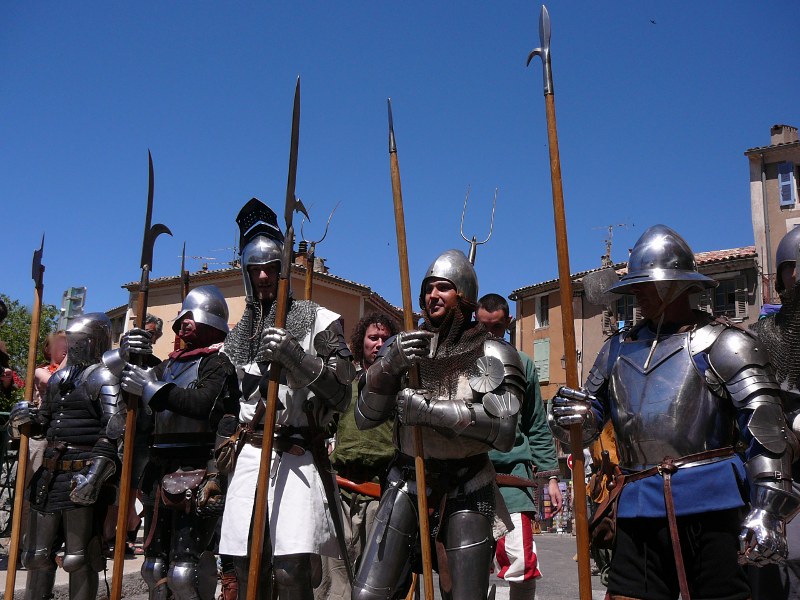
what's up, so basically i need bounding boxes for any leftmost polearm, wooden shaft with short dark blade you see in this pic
[5,234,44,600]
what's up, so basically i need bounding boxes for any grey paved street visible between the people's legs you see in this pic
[0,534,605,600]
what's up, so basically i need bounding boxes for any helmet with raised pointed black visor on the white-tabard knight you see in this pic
[236,198,283,302]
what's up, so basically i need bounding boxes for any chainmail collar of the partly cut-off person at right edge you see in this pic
[750,282,800,390]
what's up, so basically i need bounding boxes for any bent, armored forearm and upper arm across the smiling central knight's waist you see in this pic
[397,339,526,452]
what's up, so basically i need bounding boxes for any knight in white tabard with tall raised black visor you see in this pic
[219,199,355,600]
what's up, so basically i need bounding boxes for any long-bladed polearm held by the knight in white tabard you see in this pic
[247,77,308,600]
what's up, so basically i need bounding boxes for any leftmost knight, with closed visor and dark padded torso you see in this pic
[9,313,120,600]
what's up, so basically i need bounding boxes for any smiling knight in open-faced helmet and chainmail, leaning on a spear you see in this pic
[352,250,526,600]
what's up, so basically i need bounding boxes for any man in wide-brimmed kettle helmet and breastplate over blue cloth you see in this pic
[549,225,800,599]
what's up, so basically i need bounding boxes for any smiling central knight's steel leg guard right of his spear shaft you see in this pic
[442,510,493,600]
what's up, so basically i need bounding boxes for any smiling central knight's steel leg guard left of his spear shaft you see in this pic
[352,482,418,600]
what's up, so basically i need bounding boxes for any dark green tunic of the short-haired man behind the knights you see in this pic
[489,352,558,513]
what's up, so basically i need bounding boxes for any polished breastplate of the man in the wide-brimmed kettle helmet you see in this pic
[609,328,735,470]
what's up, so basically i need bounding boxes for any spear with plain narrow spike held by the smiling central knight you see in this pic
[388,98,434,600]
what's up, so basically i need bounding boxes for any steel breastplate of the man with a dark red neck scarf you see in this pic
[152,358,210,448]
